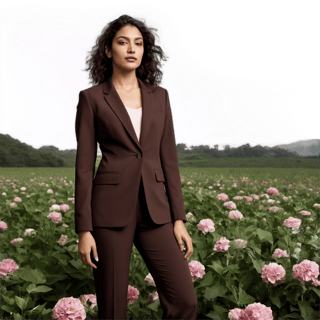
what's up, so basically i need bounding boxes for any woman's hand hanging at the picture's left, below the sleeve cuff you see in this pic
[78,231,98,269]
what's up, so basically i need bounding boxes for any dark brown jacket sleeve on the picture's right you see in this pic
[160,89,187,223]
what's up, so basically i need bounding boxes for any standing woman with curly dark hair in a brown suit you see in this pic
[75,14,197,319]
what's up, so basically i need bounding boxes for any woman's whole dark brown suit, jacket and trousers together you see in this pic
[75,78,197,319]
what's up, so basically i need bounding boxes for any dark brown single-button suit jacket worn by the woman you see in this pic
[75,77,187,234]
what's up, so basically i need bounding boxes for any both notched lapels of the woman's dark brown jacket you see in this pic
[103,77,155,151]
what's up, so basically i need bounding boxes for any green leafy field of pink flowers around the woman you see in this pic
[0,168,320,320]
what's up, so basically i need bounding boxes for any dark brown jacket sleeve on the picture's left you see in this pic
[75,91,97,234]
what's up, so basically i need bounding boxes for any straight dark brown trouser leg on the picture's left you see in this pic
[91,219,135,320]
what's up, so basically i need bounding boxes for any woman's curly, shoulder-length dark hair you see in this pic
[81,14,169,85]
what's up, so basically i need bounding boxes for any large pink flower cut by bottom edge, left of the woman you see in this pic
[52,297,87,320]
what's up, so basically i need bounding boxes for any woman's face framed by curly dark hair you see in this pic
[105,25,144,71]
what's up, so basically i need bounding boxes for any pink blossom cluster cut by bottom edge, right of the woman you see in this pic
[228,302,273,320]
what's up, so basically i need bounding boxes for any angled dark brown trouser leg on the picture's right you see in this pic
[133,178,197,320]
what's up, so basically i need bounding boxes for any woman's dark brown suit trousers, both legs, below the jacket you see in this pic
[91,176,197,320]
